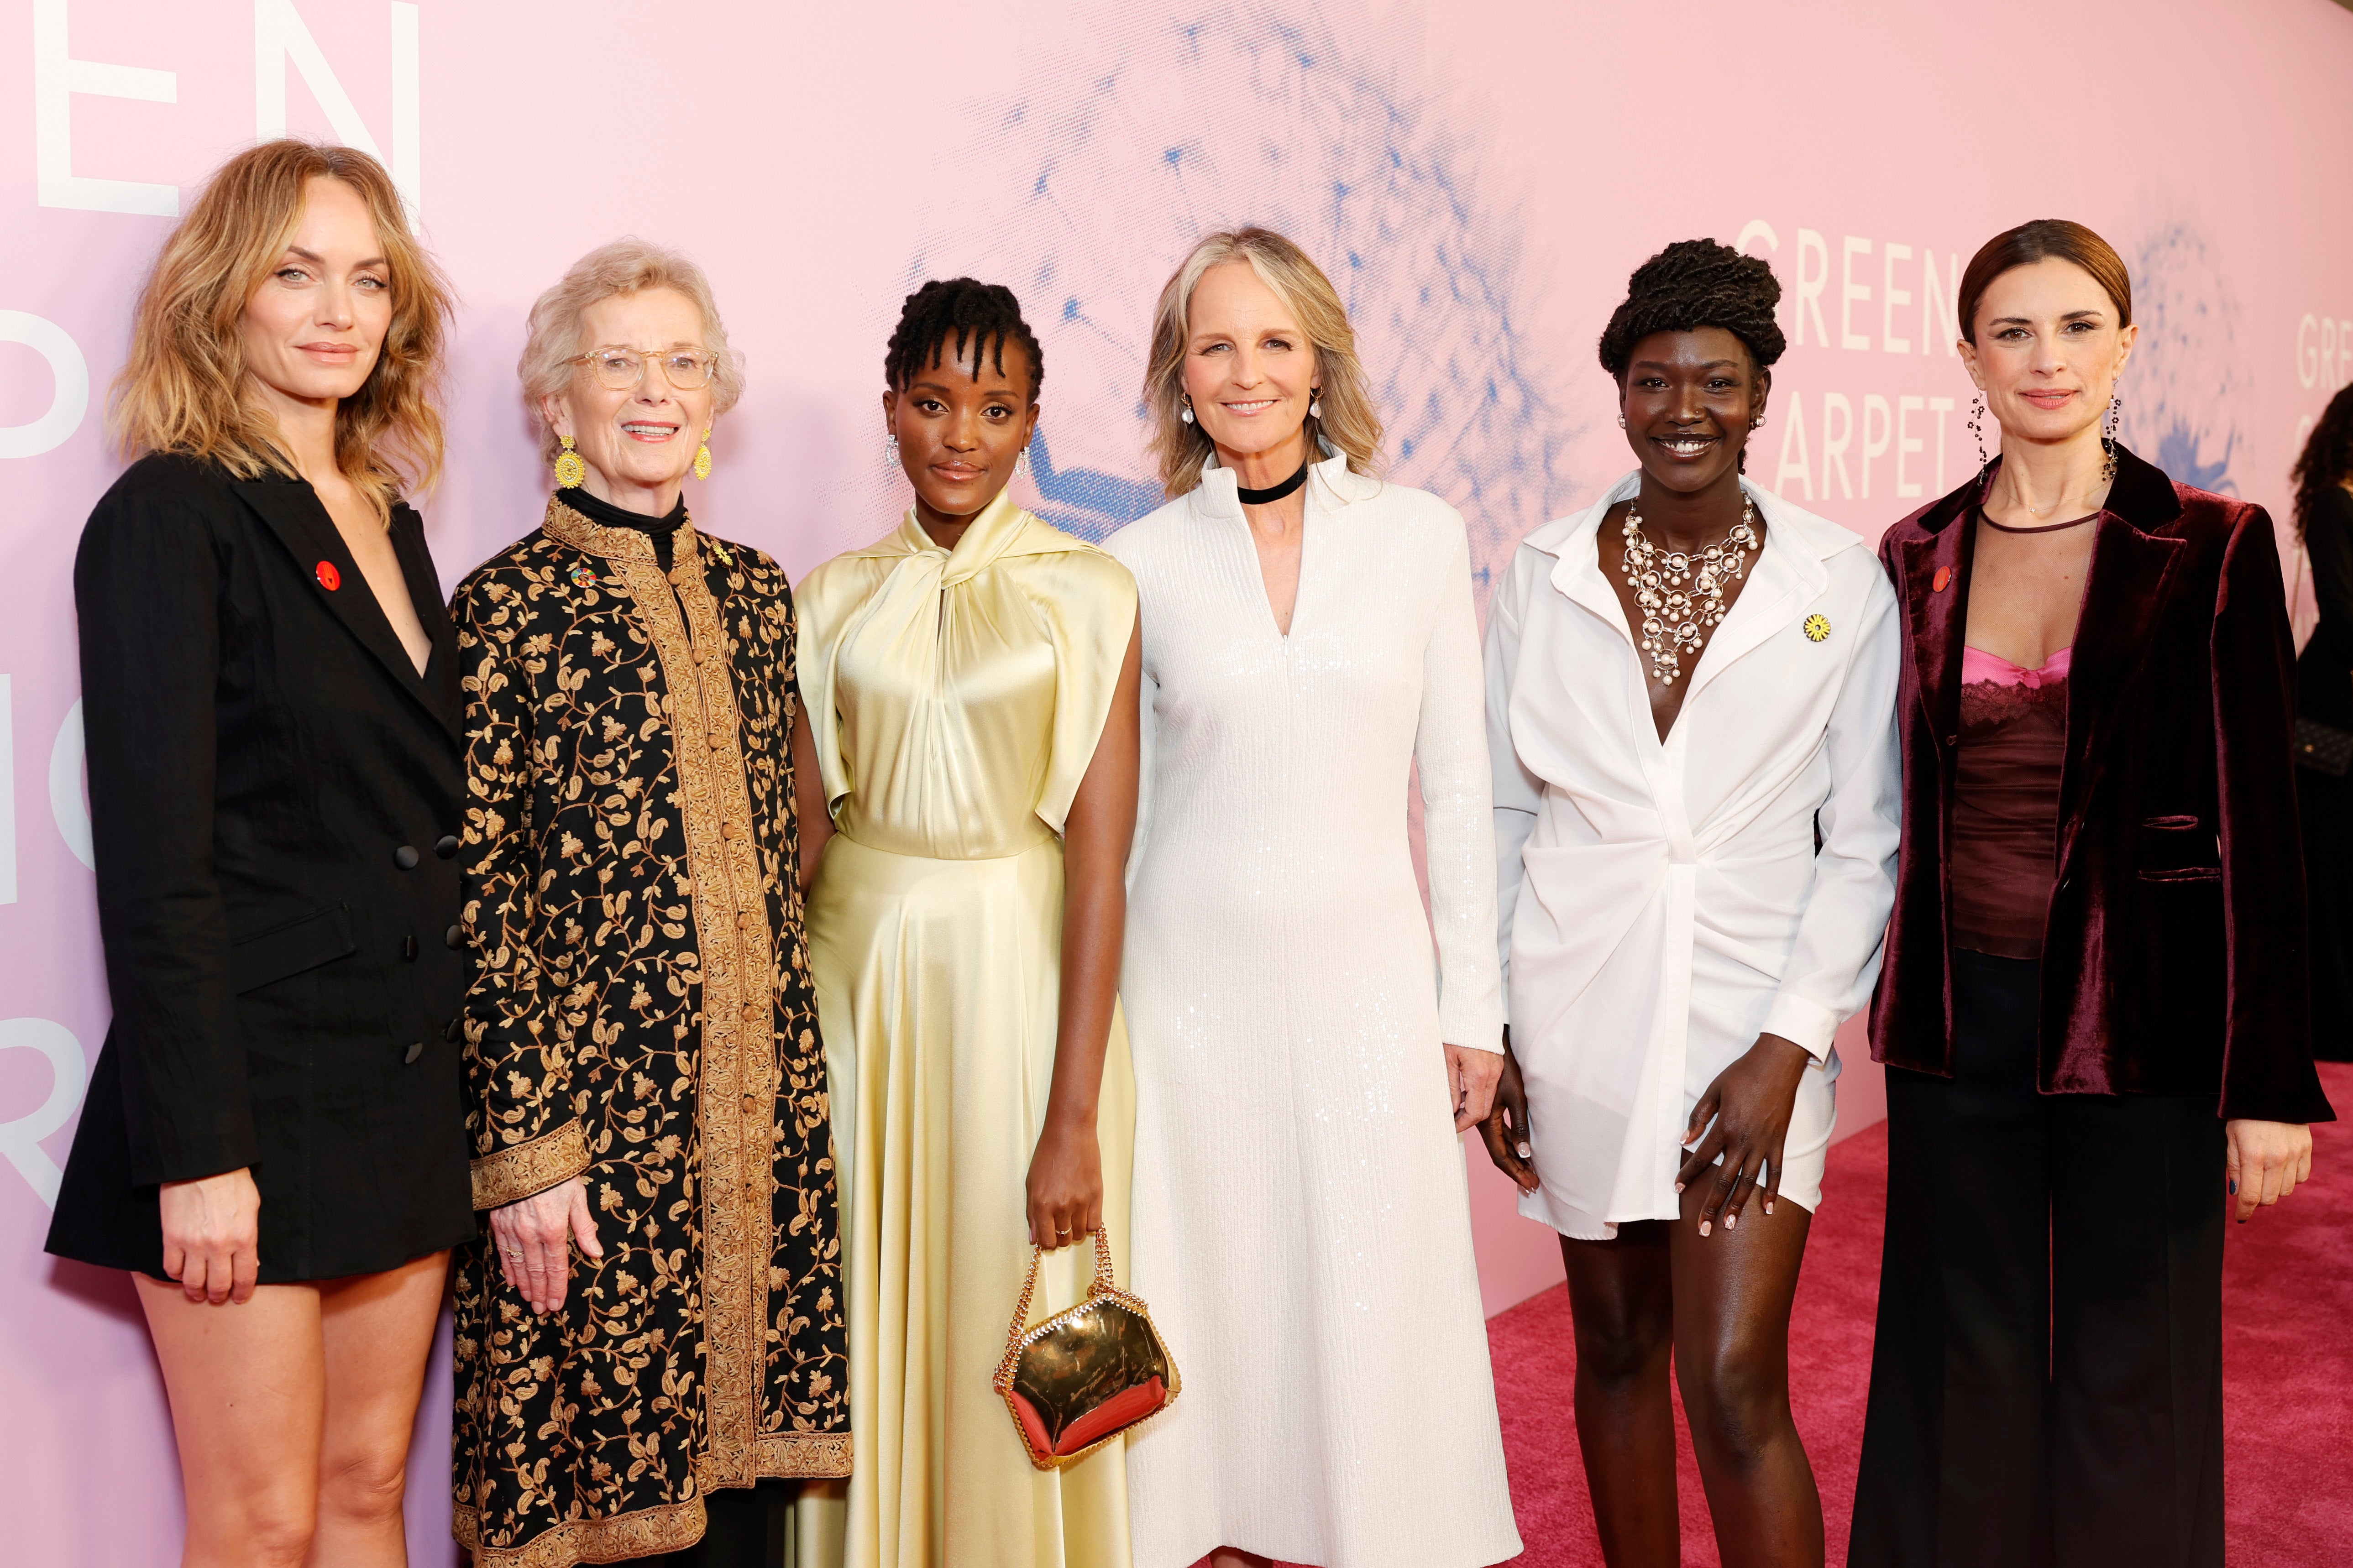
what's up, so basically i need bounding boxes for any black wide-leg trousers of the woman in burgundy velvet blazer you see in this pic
[1847,952,2223,1568]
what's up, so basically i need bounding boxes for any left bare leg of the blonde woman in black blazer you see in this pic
[132,1274,327,1568]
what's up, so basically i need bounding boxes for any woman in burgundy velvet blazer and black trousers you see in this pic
[1847,219,2329,1568]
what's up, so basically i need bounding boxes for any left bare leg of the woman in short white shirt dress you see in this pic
[1560,1220,1682,1568]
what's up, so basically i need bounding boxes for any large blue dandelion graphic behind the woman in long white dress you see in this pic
[908,5,1574,597]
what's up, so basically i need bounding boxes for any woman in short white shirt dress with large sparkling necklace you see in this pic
[1483,240,1899,1568]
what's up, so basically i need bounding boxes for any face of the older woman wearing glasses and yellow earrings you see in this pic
[541,289,713,503]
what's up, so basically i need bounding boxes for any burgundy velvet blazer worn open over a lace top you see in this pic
[1871,449,2334,1121]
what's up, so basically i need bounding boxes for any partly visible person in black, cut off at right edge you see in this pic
[2294,386,2353,1062]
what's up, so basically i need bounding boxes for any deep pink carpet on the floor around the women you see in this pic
[1195,1062,2353,1568]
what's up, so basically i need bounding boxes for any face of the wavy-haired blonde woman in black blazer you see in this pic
[242,176,393,407]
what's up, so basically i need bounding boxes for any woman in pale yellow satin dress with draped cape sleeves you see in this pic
[800,277,1141,1568]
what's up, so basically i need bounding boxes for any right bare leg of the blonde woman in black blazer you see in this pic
[310,1253,450,1568]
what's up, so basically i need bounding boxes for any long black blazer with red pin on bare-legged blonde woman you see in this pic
[49,456,473,1281]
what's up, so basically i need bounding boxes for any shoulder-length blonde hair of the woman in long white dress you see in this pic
[1143,226,1381,498]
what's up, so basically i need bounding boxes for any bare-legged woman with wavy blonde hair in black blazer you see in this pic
[49,141,473,1568]
